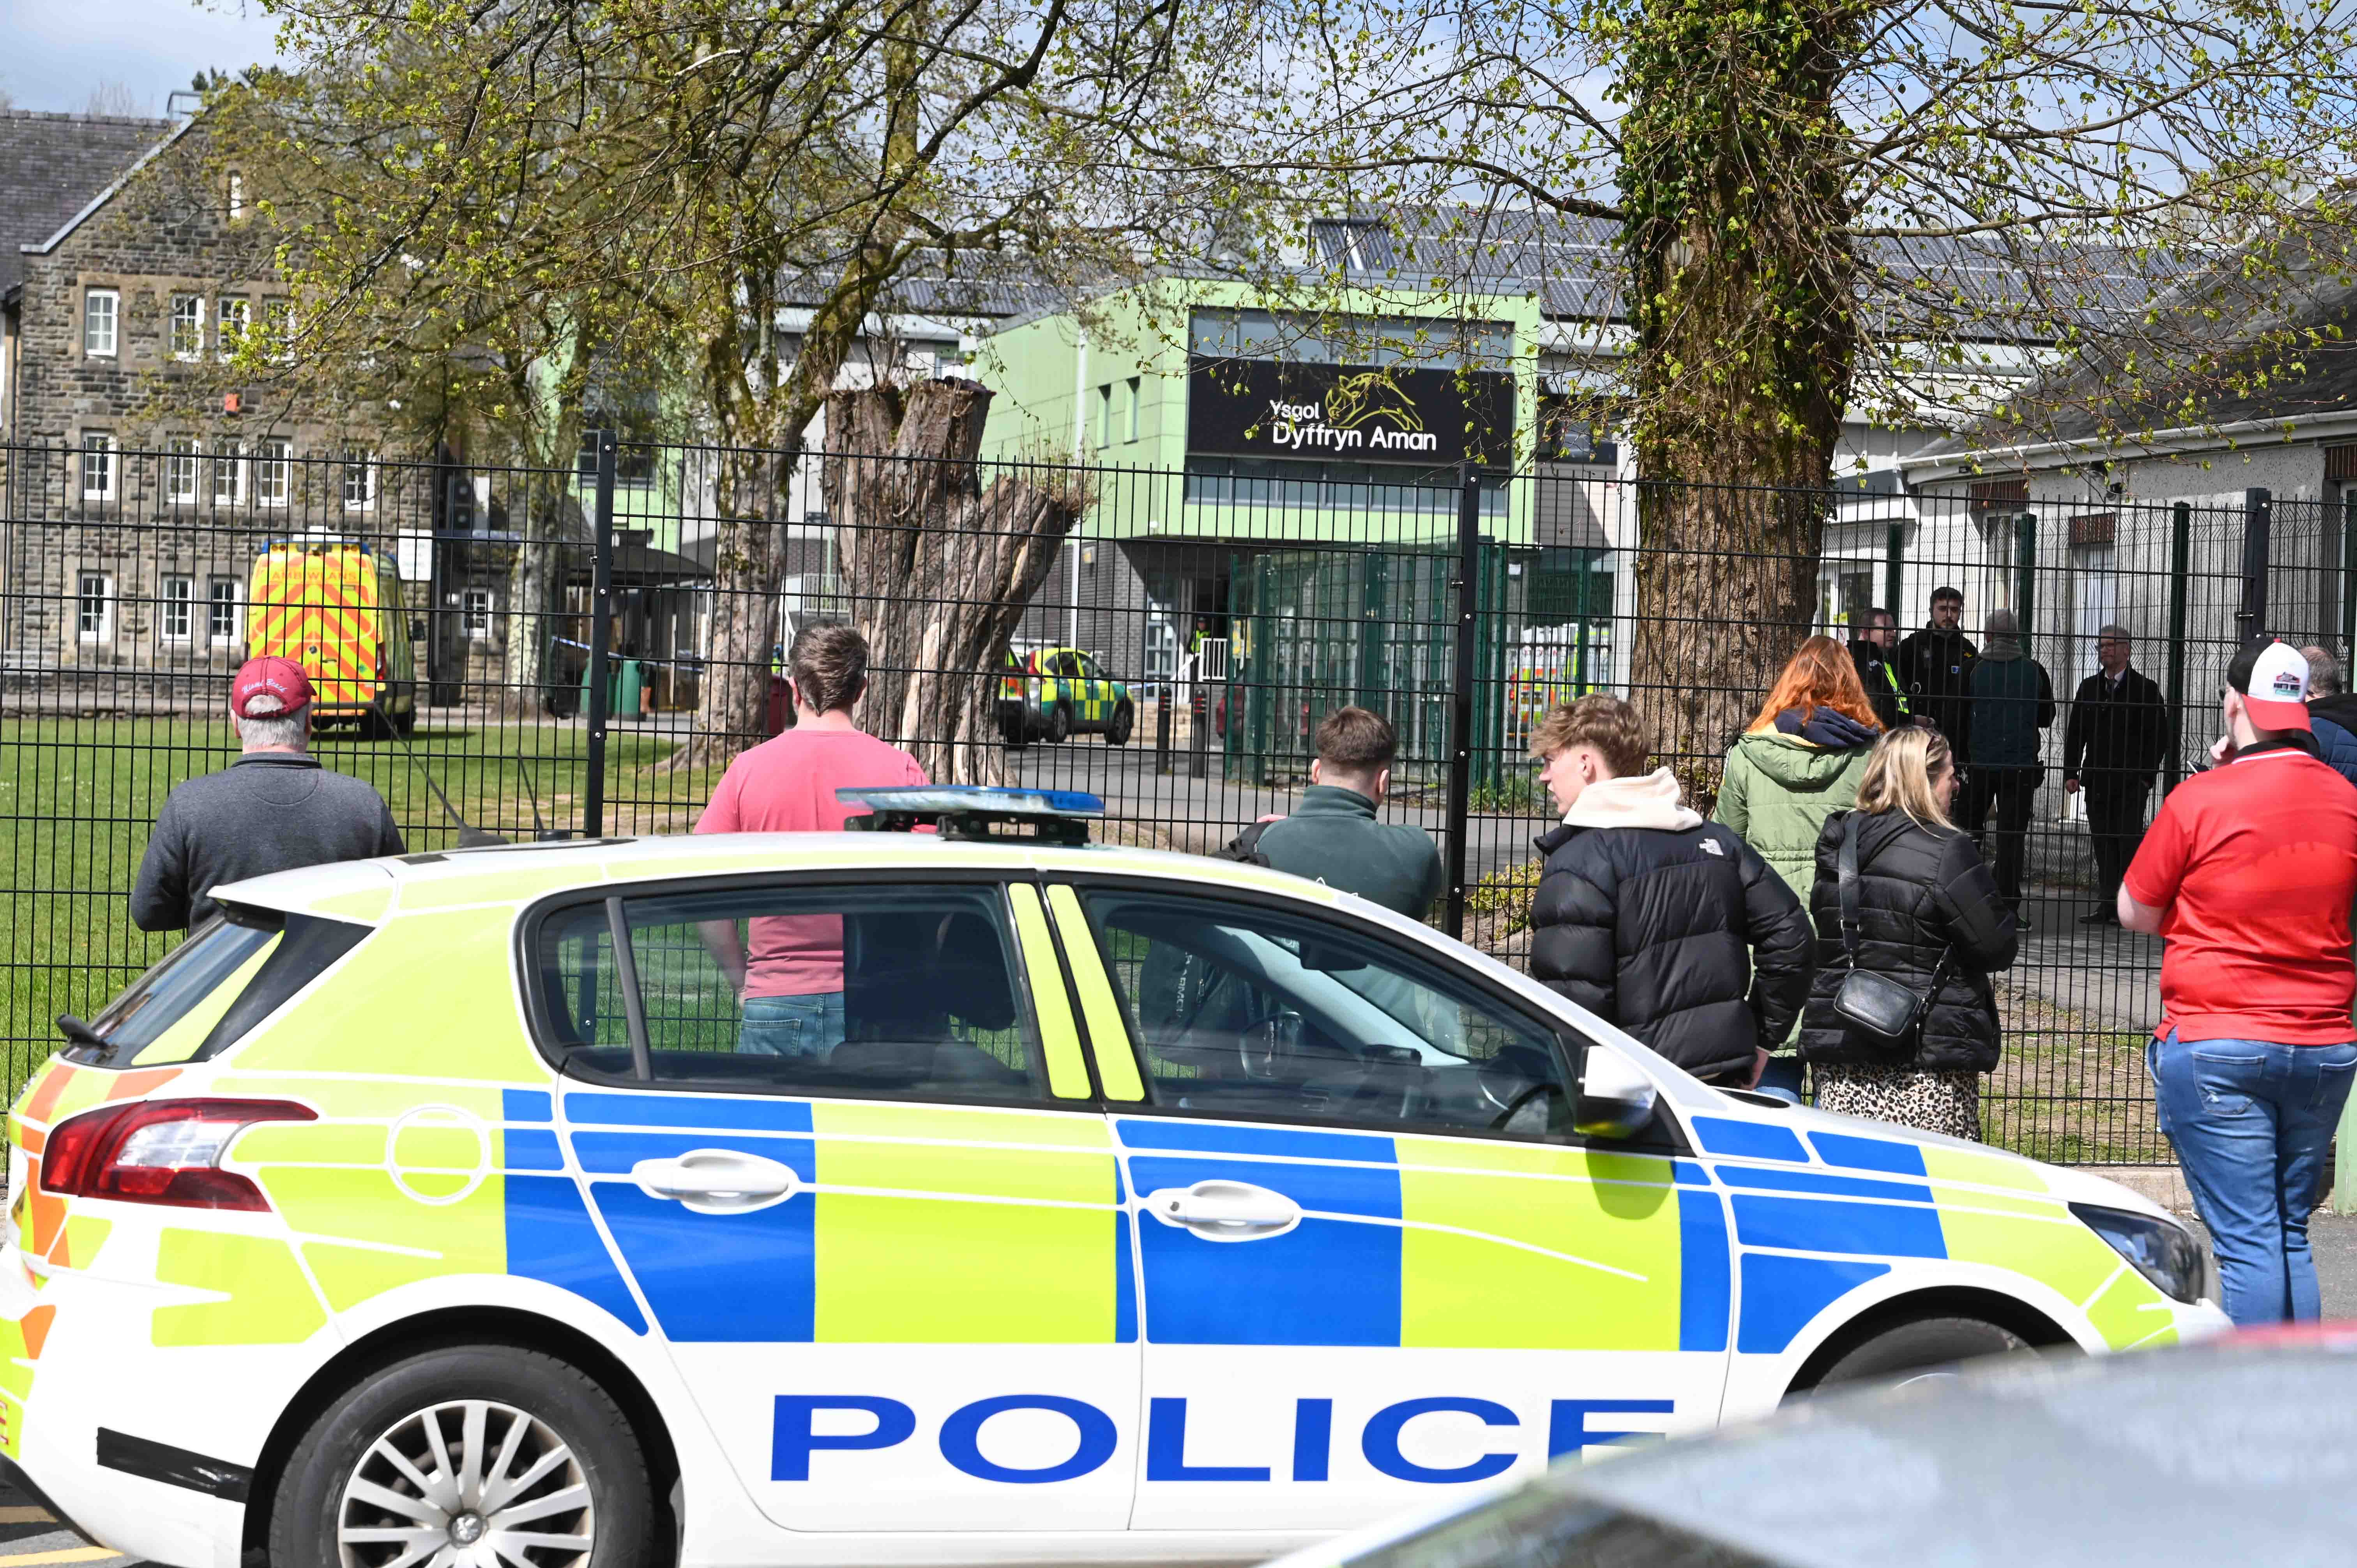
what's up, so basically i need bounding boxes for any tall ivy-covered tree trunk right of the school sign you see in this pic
[1619,0,1864,778]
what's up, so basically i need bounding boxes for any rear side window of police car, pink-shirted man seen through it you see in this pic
[535,884,1049,1101]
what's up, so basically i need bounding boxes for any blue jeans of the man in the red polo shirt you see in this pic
[2145,1033,2357,1325]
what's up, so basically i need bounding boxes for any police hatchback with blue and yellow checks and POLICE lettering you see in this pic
[0,792,2225,1568]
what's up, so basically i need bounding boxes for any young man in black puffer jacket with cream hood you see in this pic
[1530,696,1810,1087]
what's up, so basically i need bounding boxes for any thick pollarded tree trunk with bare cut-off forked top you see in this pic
[825,380,1089,783]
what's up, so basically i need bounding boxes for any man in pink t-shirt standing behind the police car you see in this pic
[695,627,931,1059]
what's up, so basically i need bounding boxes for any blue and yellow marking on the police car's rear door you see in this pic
[549,1092,1136,1344]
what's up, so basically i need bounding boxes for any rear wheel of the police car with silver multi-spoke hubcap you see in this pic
[271,1346,657,1568]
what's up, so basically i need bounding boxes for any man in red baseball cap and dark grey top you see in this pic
[132,658,403,931]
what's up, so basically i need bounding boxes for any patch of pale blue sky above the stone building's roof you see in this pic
[0,0,278,116]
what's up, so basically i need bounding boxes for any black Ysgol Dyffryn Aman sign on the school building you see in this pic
[1186,354,1513,464]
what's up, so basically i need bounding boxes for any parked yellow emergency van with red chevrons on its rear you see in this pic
[245,535,417,740]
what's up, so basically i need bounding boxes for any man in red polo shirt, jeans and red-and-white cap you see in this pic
[2119,641,2357,1323]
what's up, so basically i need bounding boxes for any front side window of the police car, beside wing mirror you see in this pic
[1084,891,1570,1137]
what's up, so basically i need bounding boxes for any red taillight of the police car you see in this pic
[40,1099,318,1210]
